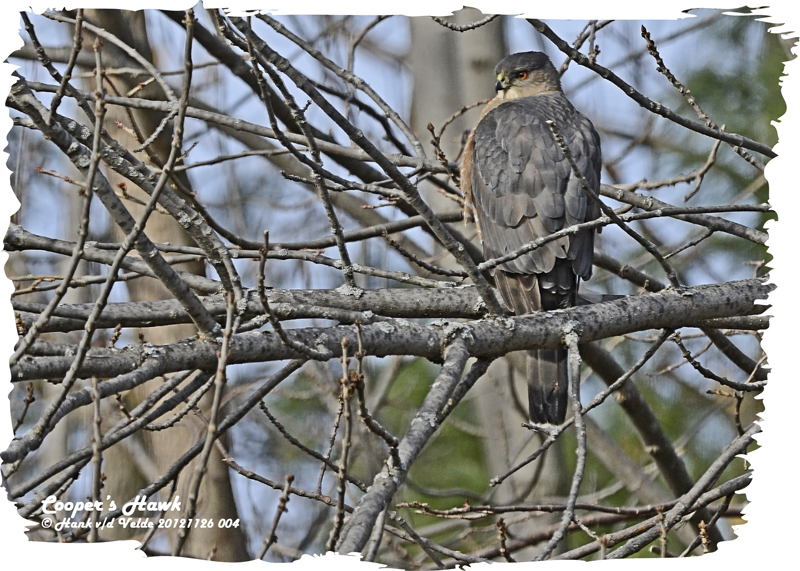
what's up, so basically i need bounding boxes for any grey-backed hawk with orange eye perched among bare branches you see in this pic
[461,52,601,424]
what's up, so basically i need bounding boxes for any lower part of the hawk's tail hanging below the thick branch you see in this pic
[527,349,569,424]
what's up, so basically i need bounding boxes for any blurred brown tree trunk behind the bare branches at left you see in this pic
[84,10,250,561]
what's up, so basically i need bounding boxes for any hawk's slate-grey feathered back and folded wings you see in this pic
[472,92,601,279]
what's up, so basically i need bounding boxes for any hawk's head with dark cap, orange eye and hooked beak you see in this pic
[494,52,561,99]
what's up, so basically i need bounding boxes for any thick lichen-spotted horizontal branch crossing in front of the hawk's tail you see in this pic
[6,279,774,382]
